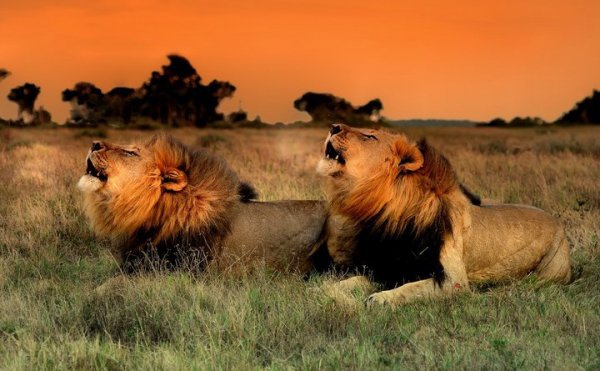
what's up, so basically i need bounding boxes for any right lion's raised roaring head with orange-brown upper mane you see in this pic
[317,125,465,233]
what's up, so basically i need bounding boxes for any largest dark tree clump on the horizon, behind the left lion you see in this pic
[62,54,235,126]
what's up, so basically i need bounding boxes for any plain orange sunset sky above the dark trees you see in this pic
[0,0,600,122]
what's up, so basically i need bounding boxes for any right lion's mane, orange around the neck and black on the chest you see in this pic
[329,135,468,287]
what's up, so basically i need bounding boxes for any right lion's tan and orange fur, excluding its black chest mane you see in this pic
[317,125,571,305]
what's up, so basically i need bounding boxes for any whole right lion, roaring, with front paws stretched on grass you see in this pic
[317,125,571,306]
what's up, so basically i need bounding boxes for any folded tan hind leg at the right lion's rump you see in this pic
[535,228,571,283]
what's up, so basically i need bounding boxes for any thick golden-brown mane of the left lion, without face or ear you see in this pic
[84,135,250,269]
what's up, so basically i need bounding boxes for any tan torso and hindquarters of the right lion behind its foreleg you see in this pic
[463,204,571,283]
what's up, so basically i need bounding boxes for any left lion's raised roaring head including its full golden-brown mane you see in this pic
[78,134,252,264]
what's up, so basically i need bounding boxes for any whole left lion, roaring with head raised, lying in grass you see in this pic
[78,134,326,273]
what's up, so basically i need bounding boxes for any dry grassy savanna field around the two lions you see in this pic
[0,127,600,370]
